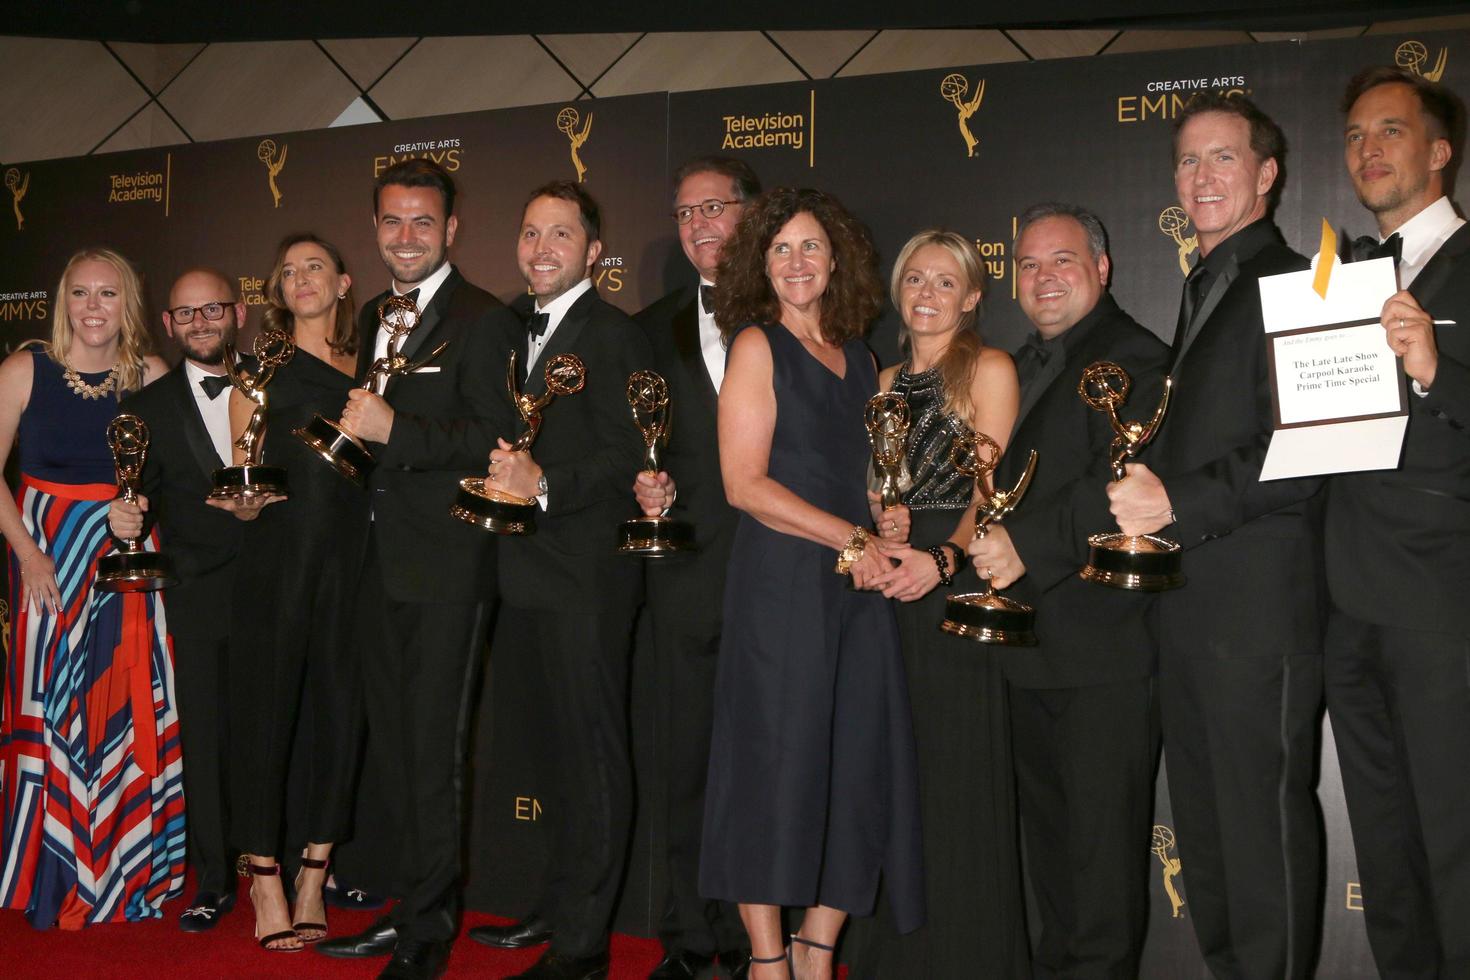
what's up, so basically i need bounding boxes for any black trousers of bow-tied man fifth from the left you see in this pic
[491,605,634,956]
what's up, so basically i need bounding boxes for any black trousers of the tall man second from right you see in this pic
[1158,631,1322,980]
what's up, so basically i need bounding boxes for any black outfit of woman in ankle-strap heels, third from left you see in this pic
[229,350,369,854]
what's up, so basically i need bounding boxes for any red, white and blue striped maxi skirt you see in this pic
[0,476,184,929]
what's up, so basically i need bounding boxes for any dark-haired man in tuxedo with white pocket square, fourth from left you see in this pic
[314,160,519,979]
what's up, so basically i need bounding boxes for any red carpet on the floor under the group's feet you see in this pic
[0,883,660,980]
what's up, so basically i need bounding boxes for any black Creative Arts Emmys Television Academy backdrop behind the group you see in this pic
[0,32,1470,977]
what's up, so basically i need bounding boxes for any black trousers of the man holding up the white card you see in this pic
[1324,608,1470,977]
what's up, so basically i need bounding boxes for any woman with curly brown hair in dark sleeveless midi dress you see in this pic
[700,188,923,980]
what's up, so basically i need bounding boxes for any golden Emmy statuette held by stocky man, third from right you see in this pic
[939,432,1036,646]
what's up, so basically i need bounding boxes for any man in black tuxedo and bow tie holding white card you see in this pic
[1326,68,1470,977]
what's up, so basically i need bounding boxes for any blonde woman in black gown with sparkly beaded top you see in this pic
[853,231,1029,980]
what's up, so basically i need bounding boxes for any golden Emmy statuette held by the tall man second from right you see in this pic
[1078,361,1185,592]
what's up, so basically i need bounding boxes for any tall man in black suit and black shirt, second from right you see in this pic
[1108,96,1322,979]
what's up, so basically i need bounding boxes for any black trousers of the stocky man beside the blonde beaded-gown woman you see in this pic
[1010,677,1158,980]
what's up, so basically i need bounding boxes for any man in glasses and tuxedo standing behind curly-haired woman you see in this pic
[634,157,760,980]
